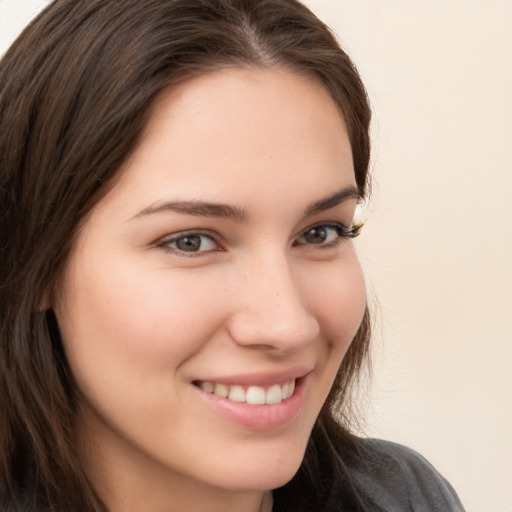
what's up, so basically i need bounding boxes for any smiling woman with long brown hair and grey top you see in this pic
[0,0,462,512]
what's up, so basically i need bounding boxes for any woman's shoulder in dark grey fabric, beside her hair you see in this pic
[352,439,464,512]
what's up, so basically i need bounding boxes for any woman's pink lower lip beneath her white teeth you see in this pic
[194,377,306,430]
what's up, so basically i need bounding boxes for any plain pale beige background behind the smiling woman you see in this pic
[0,0,512,512]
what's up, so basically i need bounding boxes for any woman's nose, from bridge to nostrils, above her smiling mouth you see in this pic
[228,251,320,353]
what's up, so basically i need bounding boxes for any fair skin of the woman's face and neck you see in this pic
[53,69,366,512]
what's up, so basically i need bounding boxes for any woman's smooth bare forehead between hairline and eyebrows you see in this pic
[101,64,355,216]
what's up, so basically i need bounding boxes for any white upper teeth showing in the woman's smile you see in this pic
[194,379,295,405]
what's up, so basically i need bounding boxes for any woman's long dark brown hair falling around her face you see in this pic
[0,0,370,511]
